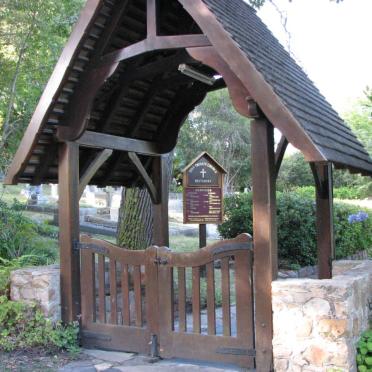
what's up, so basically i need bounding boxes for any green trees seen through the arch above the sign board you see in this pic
[173,89,251,191]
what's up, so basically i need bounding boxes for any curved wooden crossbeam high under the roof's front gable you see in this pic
[98,35,211,66]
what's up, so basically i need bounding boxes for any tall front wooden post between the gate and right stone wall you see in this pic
[251,119,278,372]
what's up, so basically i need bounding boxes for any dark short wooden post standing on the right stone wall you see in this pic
[311,163,335,279]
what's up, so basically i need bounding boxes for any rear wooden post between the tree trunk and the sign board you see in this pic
[153,155,169,247]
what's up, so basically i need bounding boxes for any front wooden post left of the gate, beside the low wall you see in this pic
[58,142,80,323]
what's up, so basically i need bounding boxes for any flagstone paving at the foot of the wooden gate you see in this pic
[59,349,246,372]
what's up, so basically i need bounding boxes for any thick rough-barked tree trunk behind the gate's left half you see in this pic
[117,153,173,250]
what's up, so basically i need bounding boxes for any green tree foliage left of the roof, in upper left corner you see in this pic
[0,0,84,170]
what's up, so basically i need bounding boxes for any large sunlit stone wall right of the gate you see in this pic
[272,261,372,372]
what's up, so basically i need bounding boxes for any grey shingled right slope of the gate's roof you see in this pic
[203,0,372,172]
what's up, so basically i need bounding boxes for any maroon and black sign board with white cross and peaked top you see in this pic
[183,152,226,224]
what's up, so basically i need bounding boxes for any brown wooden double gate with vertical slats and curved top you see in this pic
[79,234,255,367]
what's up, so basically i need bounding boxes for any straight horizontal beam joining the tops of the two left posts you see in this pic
[76,131,161,156]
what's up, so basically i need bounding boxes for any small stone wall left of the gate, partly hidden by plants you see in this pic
[10,265,61,321]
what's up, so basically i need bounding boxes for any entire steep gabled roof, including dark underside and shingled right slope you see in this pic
[6,0,372,186]
